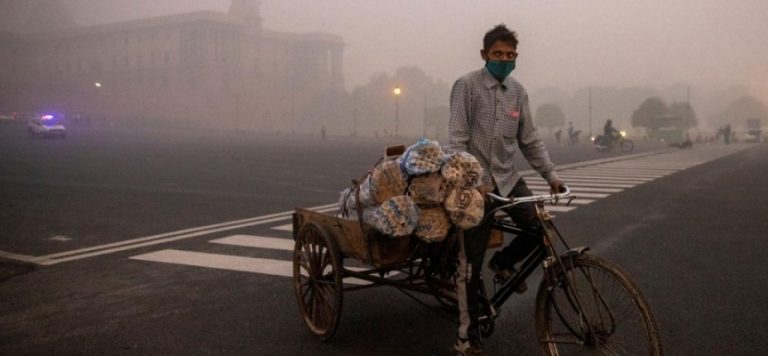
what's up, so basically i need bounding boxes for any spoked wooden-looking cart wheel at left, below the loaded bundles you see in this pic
[293,223,342,340]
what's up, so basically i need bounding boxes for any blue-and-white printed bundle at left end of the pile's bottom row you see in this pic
[372,195,419,237]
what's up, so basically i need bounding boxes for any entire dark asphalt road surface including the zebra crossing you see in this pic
[0,124,768,355]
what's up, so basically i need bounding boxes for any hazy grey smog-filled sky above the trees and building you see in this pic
[63,0,768,94]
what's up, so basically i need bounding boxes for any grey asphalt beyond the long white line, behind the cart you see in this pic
[0,125,658,256]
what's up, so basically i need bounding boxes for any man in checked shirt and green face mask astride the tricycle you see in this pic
[448,24,563,355]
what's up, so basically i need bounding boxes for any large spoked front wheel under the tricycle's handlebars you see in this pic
[536,254,662,355]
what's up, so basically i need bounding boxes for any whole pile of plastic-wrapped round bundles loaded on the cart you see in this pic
[341,139,484,242]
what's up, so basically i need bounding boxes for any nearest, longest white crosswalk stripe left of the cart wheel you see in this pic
[130,249,369,284]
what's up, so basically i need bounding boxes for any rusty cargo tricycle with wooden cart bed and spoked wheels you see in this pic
[293,188,662,355]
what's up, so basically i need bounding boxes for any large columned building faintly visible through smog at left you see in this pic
[0,0,344,132]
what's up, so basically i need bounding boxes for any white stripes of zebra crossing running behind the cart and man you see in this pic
[130,146,756,284]
